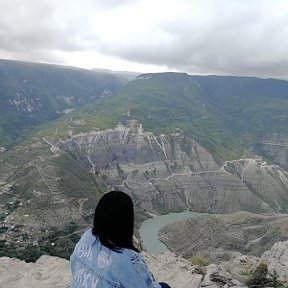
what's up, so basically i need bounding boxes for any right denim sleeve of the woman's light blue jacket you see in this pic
[121,252,161,288]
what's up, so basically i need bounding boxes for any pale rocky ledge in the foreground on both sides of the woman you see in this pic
[0,241,288,288]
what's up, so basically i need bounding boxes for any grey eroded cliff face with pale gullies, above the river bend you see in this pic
[61,121,288,214]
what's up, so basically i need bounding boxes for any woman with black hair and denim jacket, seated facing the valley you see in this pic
[70,191,170,288]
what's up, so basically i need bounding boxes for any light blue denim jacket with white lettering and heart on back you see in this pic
[70,228,161,288]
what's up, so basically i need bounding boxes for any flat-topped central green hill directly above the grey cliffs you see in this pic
[39,73,237,158]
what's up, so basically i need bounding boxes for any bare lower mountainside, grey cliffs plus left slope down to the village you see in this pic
[0,121,288,256]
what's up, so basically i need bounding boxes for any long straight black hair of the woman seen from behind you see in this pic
[92,191,138,252]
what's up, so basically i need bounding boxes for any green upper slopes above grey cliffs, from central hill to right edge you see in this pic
[40,73,288,160]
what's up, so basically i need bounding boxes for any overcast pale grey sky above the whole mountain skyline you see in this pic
[0,0,288,79]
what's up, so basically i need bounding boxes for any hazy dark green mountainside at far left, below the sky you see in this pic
[0,60,128,148]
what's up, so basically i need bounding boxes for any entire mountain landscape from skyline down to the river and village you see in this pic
[0,61,288,264]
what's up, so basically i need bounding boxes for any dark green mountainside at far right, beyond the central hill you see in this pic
[193,76,288,138]
